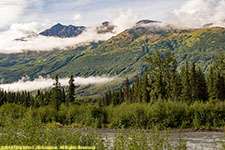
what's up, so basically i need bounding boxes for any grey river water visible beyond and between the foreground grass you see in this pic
[97,130,225,150]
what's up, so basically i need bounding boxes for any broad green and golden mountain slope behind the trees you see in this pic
[0,22,225,94]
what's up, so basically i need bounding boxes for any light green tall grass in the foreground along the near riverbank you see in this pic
[0,117,187,150]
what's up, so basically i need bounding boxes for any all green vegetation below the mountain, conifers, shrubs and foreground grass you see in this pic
[0,51,225,150]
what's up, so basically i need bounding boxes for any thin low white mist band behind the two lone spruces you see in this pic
[0,76,115,92]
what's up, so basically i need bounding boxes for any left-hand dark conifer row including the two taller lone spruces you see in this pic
[0,75,75,111]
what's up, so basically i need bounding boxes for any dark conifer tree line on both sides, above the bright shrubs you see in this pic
[0,51,225,111]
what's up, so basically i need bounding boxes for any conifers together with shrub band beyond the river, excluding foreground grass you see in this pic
[0,51,225,130]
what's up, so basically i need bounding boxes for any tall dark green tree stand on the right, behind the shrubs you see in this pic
[102,51,225,106]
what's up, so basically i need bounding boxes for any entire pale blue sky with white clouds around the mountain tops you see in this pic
[0,0,225,53]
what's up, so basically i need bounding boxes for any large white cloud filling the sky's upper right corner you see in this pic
[171,0,225,27]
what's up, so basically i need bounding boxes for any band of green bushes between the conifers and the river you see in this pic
[0,100,225,129]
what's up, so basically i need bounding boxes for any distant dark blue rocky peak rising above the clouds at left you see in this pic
[40,23,86,38]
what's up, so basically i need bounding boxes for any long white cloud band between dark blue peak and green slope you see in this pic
[0,27,114,53]
